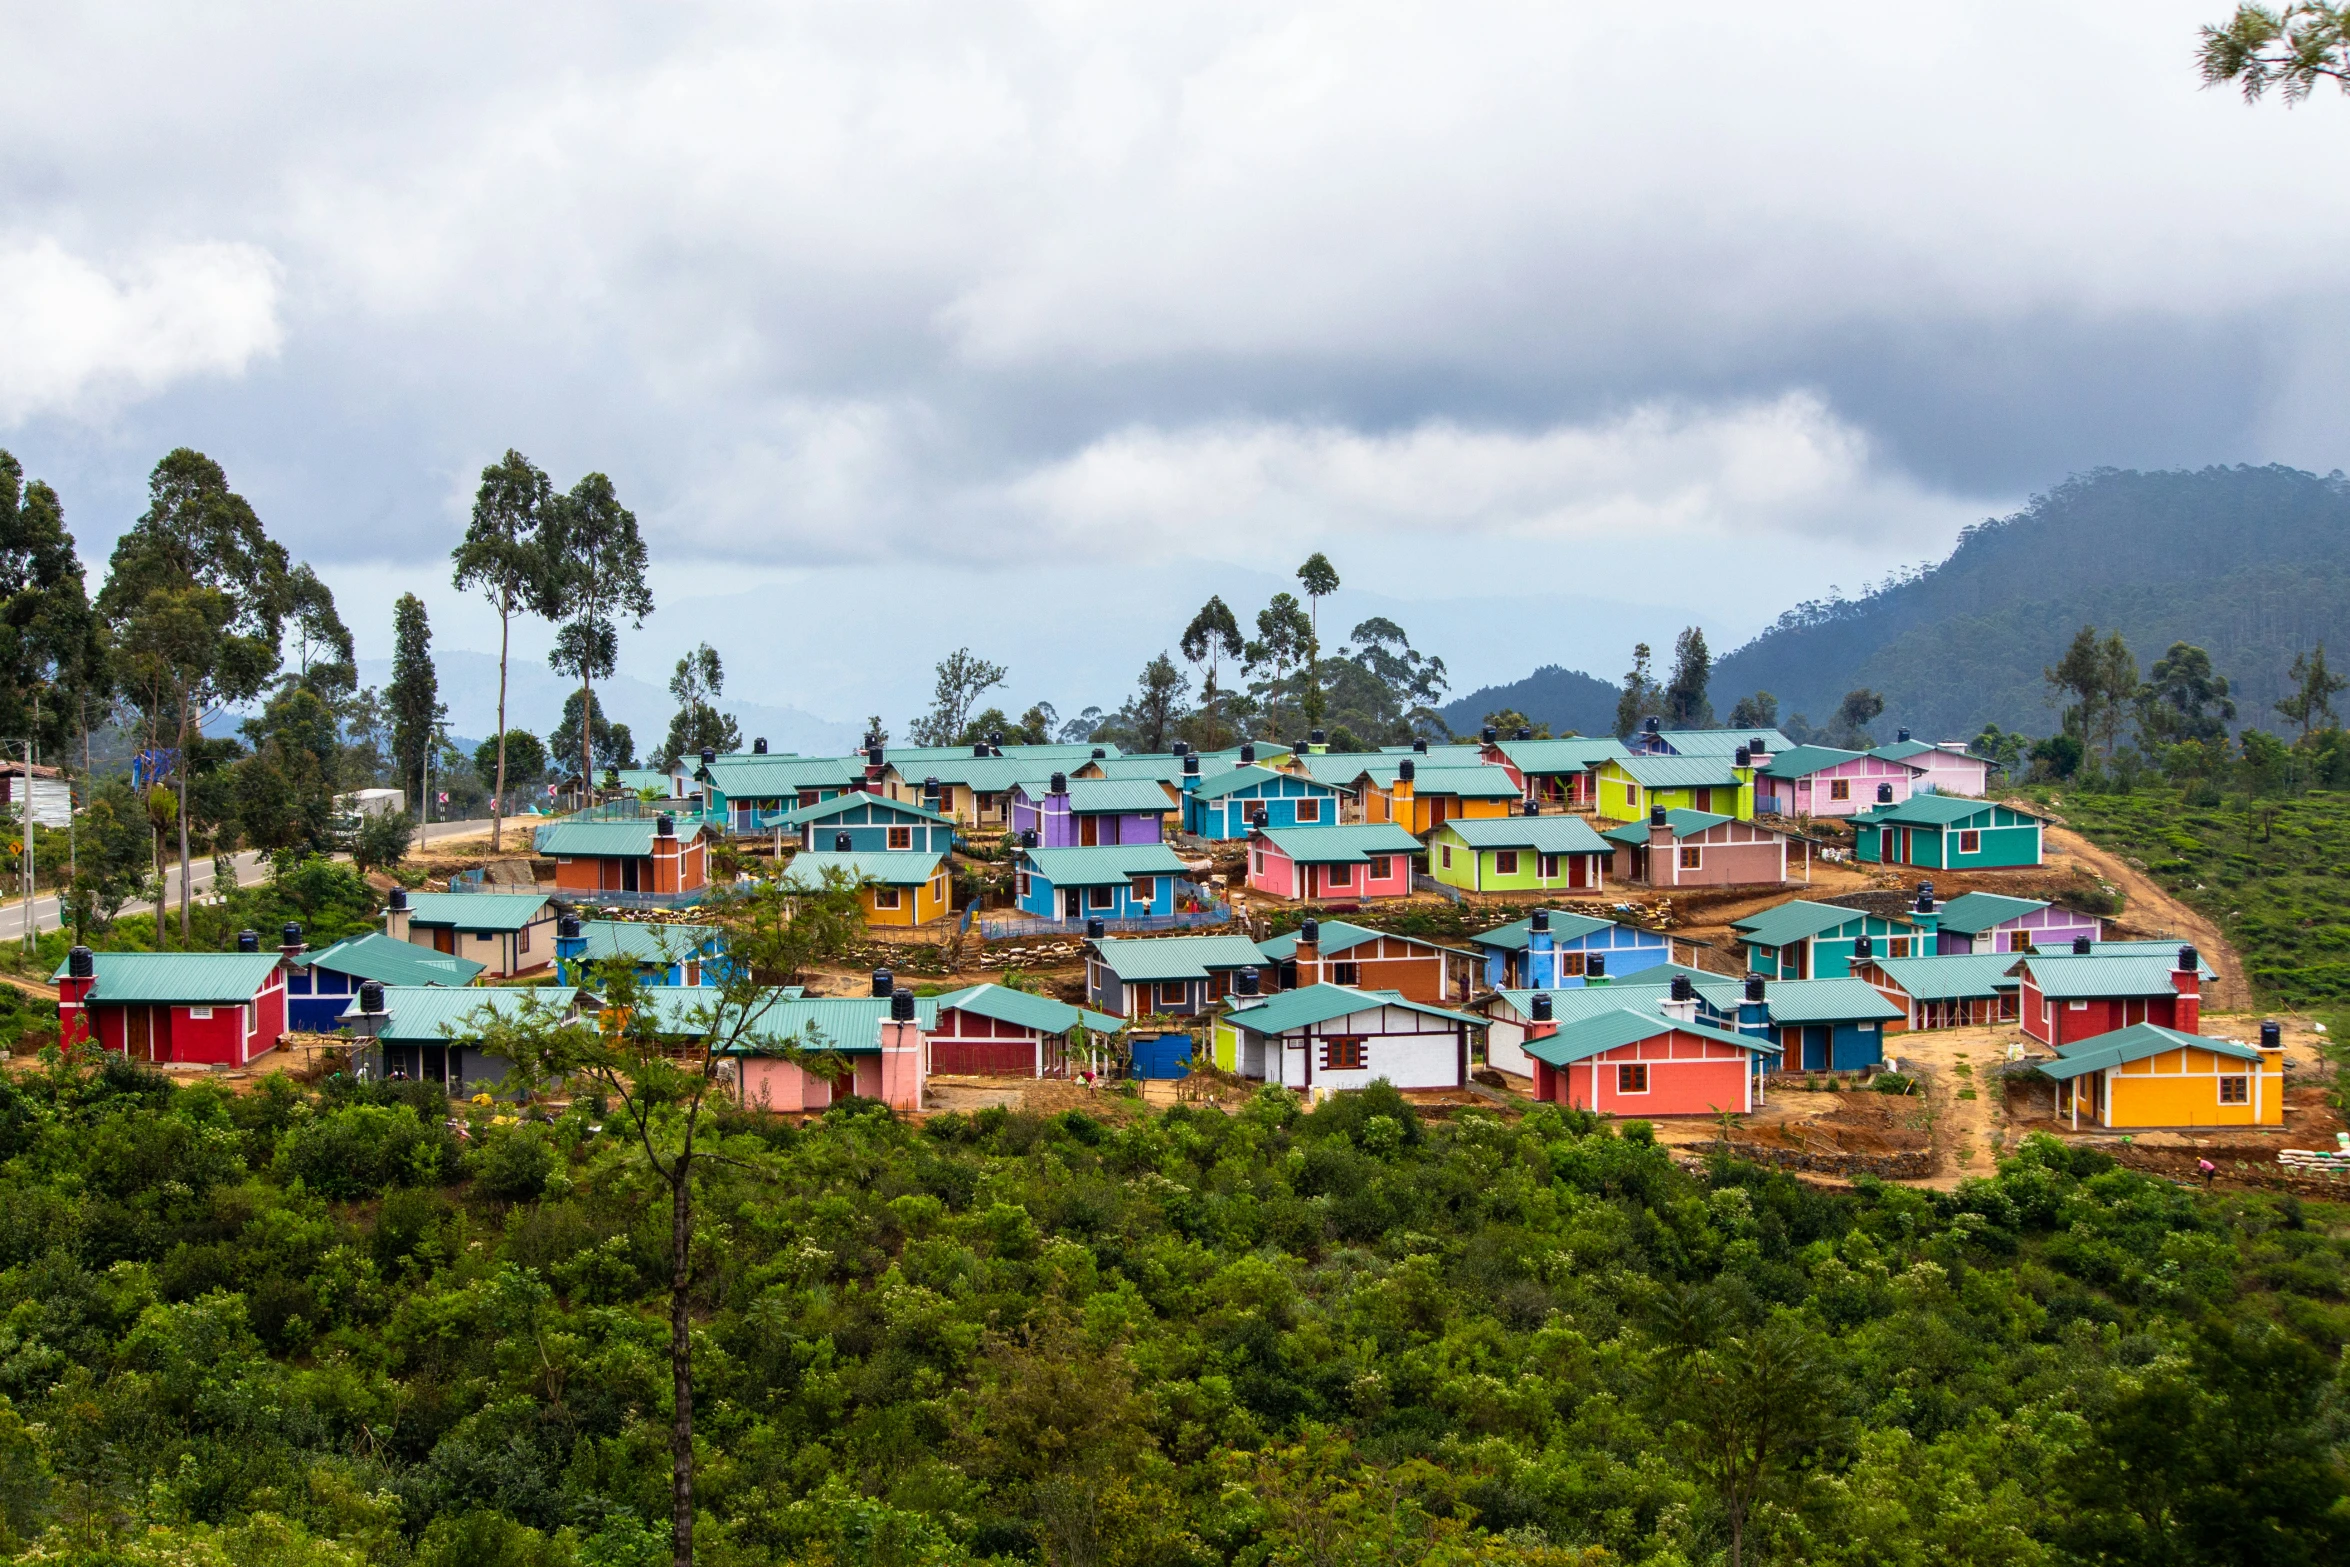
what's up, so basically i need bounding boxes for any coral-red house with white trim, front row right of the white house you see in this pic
[1525,977,1779,1118]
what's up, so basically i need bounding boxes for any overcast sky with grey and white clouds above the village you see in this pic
[0,0,2350,721]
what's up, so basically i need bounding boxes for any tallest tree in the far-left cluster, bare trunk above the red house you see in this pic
[99,446,291,942]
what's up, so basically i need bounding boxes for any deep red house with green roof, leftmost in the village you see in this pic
[54,947,287,1067]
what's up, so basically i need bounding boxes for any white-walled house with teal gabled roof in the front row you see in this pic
[1210,984,1485,1090]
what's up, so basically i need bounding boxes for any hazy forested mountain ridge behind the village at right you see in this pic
[1445,465,2350,740]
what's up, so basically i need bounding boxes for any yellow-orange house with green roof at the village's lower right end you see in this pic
[2040,1022,2284,1130]
